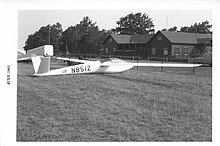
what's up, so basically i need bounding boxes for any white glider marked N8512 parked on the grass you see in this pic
[31,56,202,76]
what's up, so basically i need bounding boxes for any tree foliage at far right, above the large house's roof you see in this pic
[180,21,212,34]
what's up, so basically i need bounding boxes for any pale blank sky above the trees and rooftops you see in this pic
[18,9,212,50]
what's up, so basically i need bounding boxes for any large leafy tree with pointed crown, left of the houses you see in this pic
[61,17,105,54]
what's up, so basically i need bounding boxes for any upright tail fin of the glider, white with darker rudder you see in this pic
[31,56,50,75]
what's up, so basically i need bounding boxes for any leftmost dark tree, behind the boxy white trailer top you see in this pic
[24,22,63,54]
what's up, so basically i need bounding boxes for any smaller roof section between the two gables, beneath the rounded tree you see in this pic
[110,34,153,44]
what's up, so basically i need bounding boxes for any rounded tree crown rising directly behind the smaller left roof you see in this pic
[114,13,154,35]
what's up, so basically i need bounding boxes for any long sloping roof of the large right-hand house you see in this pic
[160,31,212,44]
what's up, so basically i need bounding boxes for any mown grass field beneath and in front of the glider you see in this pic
[17,60,212,141]
